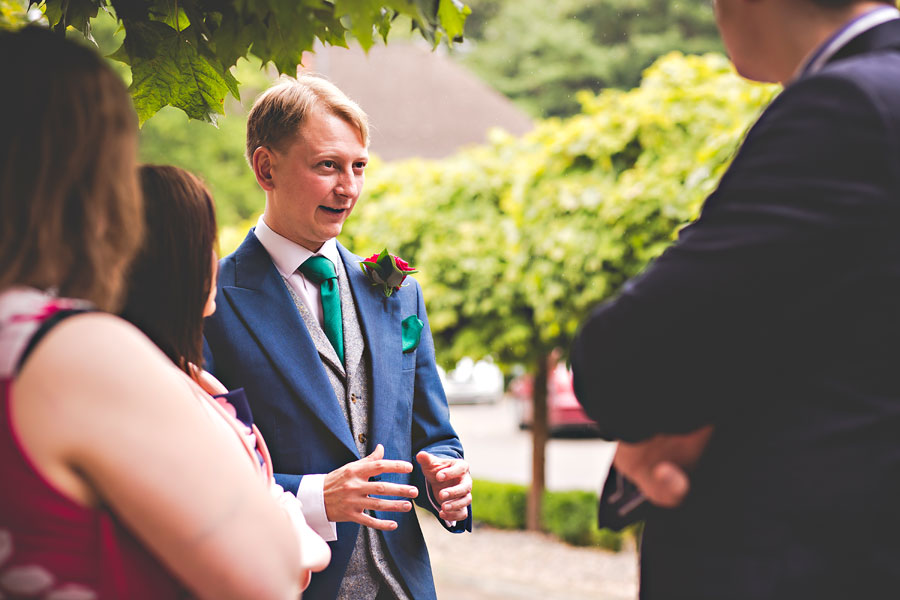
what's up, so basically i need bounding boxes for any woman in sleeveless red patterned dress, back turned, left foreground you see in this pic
[0,28,302,600]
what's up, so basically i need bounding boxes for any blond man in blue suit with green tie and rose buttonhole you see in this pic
[205,75,472,600]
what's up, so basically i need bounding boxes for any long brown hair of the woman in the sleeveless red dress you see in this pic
[0,27,142,310]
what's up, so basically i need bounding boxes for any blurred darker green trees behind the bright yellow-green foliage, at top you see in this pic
[464,0,722,117]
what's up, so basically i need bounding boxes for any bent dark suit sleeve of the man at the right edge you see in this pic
[572,74,897,441]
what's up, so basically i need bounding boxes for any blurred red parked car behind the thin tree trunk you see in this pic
[509,364,599,435]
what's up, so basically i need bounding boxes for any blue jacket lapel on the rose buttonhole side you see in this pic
[337,244,403,442]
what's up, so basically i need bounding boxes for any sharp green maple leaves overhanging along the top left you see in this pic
[26,0,469,123]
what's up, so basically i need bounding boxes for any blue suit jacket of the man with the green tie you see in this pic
[204,230,471,600]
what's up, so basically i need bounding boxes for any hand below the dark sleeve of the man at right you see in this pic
[613,425,713,508]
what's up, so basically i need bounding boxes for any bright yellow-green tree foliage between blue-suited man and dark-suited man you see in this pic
[344,54,775,365]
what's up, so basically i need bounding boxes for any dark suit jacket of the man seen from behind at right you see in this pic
[572,21,900,600]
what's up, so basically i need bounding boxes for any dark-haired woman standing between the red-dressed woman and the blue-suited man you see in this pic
[121,165,331,587]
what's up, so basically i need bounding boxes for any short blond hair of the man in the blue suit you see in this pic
[246,73,369,166]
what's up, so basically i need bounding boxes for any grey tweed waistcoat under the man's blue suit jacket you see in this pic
[285,260,409,600]
